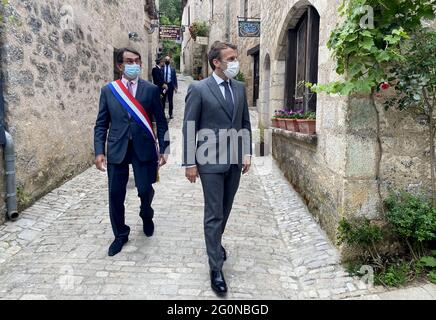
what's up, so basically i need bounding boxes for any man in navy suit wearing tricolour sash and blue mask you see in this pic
[94,48,169,256]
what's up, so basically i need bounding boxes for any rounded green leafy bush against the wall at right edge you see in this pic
[385,192,436,242]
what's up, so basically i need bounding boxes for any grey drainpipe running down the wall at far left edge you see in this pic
[0,73,19,221]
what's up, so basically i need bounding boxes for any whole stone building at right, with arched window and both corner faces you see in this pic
[258,0,431,246]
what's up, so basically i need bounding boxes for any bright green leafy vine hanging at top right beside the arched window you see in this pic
[309,0,435,95]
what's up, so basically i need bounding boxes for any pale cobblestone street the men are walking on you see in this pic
[0,77,436,300]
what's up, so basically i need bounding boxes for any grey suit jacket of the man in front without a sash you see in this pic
[183,76,253,173]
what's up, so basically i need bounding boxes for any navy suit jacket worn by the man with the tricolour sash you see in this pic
[94,79,170,164]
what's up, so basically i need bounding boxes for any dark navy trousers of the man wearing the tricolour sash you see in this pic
[107,141,157,239]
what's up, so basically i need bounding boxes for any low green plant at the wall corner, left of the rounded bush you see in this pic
[337,218,384,266]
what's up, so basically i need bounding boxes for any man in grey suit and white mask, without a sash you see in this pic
[183,41,252,296]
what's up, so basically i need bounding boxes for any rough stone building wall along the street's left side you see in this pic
[0,0,158,222]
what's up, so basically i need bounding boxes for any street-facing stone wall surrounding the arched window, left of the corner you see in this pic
[258,0,347,239]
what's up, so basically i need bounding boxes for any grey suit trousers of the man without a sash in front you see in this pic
[200,165,241,271]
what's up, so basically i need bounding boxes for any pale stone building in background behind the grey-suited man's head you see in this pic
[182,0,261,106]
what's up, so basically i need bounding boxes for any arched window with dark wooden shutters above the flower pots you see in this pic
[285,7,320,111]
